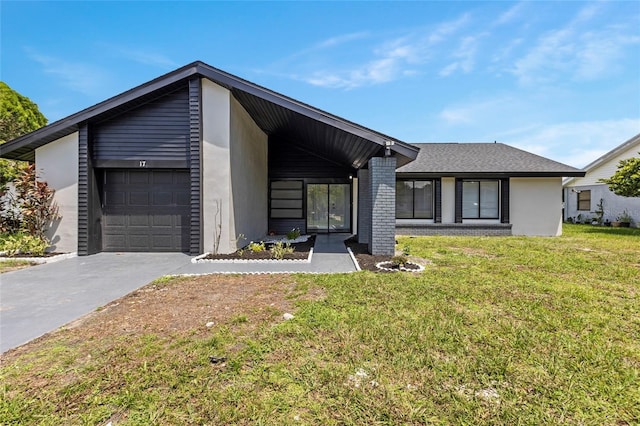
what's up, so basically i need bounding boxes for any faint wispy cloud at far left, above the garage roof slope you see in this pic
[26,49,112,97]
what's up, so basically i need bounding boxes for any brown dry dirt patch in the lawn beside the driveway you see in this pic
[0,275,323,363]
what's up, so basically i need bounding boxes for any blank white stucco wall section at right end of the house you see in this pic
[509,177,562,236]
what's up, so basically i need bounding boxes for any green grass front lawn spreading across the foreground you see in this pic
[0,225,640,425]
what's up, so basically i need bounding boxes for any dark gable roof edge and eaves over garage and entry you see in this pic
[0,61,418,168]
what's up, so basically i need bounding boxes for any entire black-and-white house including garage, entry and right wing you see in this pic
[0,62,582,255]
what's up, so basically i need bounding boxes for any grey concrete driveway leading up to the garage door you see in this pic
[0,253,191,353]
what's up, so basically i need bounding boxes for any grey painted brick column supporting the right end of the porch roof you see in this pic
[369,157,396,255]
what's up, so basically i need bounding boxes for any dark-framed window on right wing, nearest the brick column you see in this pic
[396,180,433,219]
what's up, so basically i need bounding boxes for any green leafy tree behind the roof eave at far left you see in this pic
[0,81,47,188]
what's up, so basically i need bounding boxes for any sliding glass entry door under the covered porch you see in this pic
[307,183,351,232]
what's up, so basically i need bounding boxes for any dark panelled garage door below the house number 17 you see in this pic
[102,169,190,252]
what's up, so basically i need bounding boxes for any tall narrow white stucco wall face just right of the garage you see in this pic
[201,78,235,253]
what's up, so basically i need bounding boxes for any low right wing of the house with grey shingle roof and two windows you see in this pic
[396,143,582,236]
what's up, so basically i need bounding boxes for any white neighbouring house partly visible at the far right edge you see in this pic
[562,134,640,226]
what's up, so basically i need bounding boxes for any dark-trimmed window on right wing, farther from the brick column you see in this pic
[462,180,500,219]
